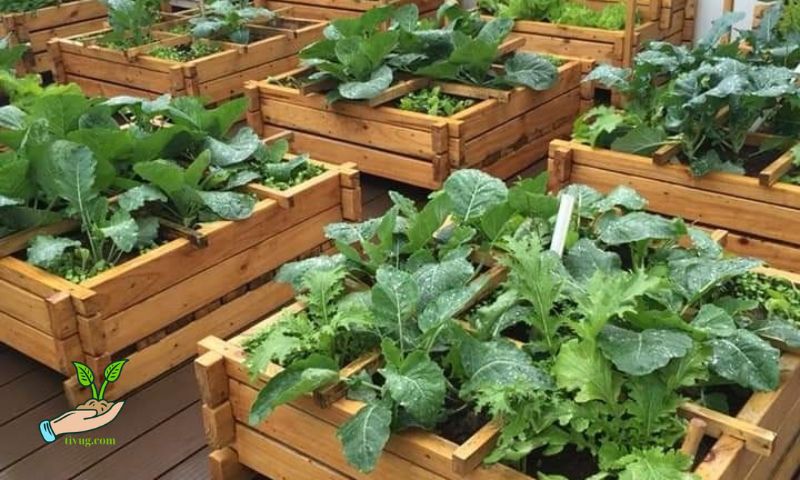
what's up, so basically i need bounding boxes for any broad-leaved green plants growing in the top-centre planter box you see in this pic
[300,2,558,101]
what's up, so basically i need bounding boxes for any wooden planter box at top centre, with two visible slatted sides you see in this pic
[245,56,594,189]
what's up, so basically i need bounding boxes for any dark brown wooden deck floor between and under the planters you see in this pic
[0,174,426,480]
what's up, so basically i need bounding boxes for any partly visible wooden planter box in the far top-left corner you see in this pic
[0,0,107,74]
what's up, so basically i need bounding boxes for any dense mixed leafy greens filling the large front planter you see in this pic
[245,170,800,479]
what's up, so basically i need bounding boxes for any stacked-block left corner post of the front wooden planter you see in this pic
[194,350,235,451]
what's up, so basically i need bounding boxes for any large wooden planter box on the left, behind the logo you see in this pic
[0,142,361,404]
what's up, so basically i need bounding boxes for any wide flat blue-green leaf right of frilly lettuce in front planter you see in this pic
[599,325,692,376]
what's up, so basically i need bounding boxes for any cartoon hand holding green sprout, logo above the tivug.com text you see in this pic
[39,360,127,443]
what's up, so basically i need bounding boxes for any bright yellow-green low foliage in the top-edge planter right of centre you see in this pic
[478,0,636,30]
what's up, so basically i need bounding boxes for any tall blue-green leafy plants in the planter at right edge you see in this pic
[573,14,800,175]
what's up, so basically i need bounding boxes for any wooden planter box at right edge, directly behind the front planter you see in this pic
[549,136,800,272]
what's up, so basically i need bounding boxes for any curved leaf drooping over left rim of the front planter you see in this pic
[248,355,339,425]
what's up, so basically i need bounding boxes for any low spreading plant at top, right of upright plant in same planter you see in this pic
[189,0,276,44]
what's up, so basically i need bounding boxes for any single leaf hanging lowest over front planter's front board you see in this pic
[336,400,392,473]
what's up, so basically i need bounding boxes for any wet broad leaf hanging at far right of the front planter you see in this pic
[710,330,780,391]
